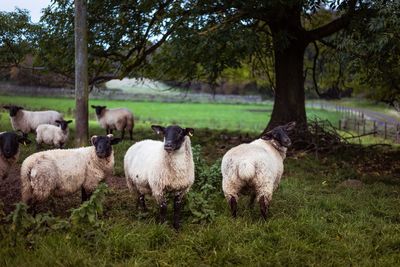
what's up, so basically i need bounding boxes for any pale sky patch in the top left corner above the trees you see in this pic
[0,0,51,22]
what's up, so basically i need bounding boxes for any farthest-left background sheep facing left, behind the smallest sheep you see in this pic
[3,105,63,136]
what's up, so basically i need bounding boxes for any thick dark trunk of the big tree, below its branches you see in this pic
[265,35,307,131]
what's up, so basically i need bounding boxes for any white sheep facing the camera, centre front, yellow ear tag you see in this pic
[124,125,194,230]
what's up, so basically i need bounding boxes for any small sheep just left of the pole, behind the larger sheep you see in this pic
[36,120,72,150]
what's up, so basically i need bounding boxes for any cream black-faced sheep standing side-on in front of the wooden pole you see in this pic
[20,134,120,209]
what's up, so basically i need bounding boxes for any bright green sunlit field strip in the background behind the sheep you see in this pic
[0,96,340,133]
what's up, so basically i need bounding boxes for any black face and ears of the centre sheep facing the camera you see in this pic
[151,125,194,153]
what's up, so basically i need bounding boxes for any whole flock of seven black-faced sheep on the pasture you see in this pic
[0,105,295,229]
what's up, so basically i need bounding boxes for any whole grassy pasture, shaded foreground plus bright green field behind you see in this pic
[0,96,400,266]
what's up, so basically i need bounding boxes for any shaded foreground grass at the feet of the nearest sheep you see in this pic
[0,148,400,266]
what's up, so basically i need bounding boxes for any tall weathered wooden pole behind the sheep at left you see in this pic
[75,0,89,146]
